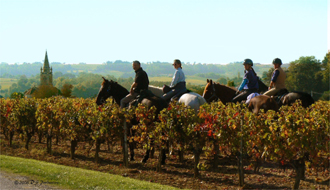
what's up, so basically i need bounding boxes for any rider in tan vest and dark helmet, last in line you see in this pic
[264,58,286,96]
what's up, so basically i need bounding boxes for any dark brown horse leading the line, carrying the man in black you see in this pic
[96,77,168,164]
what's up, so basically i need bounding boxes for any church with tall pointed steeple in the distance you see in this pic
[24,51,61,98]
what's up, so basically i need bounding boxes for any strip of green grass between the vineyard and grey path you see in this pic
[0,155,180,189]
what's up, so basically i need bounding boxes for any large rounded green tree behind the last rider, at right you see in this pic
[286,56,323,92]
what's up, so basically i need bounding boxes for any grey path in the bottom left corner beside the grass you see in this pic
[0,170,60,190]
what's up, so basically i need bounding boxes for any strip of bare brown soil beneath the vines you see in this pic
[0,134,330,189]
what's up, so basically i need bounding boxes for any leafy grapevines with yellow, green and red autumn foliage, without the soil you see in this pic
[0,97,330,189]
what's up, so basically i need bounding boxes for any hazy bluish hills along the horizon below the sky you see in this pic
[0,61,289,78]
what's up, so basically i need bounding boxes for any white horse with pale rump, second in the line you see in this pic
[148,85,206,113]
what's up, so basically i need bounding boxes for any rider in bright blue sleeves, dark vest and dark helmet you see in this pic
[232,59,259,103]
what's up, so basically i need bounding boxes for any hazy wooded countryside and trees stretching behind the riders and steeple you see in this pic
[0,52,330,100]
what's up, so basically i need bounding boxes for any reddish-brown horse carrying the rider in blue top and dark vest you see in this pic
[203,79,278,113]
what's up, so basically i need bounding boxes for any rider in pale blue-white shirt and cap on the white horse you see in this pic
[162,59,187,101]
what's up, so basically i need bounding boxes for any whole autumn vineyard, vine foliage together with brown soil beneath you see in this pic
[0,98,330,189]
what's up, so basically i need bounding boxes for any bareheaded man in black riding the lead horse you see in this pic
[120,61,149,108]
